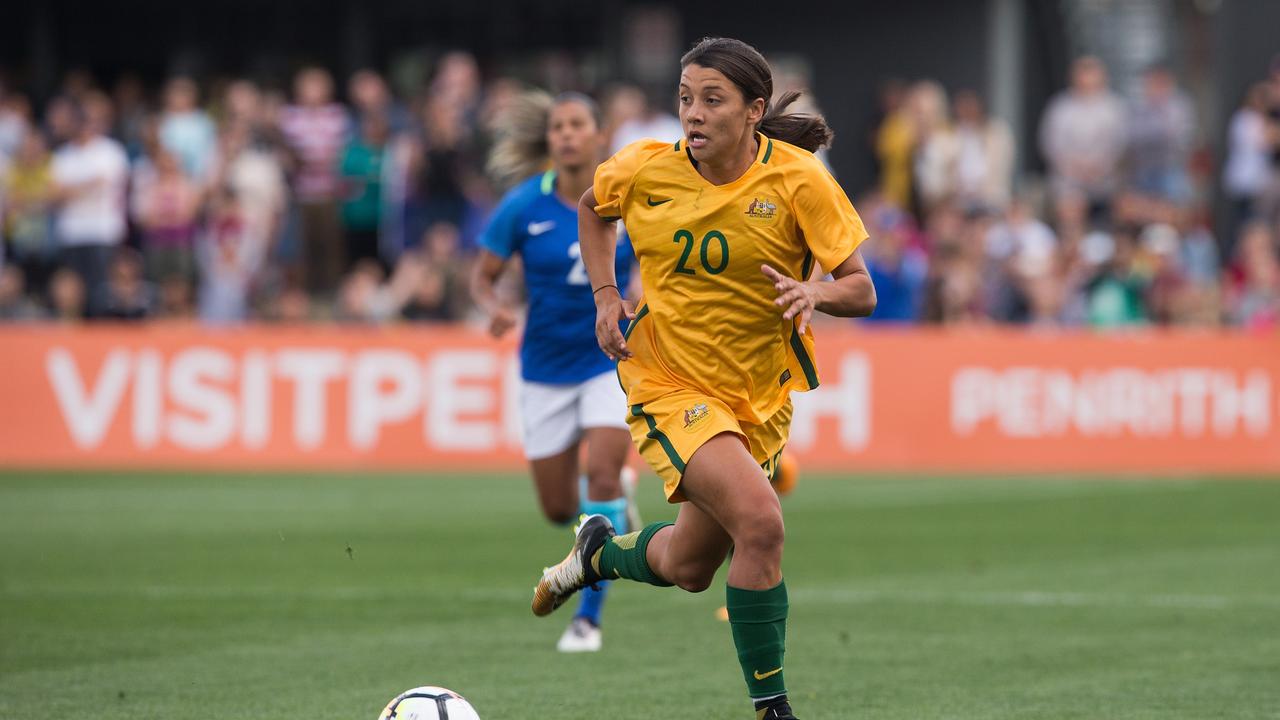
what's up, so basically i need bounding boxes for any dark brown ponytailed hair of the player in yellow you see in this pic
[680,37,835,152]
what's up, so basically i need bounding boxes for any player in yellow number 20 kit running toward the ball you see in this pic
[534,38,876,720]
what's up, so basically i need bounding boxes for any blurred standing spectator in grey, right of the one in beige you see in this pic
[1129,64,1196,204]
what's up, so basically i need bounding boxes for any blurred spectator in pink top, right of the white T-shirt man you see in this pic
[133,147,201,283]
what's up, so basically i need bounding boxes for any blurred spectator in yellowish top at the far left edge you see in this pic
[0,131,58,288]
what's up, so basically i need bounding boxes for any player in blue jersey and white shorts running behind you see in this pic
[471,88,634,652]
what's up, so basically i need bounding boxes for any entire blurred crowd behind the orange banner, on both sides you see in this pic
[0,53,1280,328]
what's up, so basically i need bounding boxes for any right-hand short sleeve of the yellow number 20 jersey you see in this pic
[794,160,867,273]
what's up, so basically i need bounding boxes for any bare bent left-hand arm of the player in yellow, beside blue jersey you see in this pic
[577,187,636,361]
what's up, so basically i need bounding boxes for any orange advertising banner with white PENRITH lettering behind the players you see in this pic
[0,324,1280,475]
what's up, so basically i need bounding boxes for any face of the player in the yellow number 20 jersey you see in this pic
[680,64,764,164]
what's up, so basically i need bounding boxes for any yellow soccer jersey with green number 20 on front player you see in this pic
[594,135,867,423]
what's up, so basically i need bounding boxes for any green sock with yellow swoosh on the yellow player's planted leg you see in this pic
[724,583,787,698]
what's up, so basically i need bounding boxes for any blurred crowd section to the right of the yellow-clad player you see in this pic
[855,56,1280,329]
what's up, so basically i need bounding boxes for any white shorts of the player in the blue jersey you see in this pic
[520,372,627,460]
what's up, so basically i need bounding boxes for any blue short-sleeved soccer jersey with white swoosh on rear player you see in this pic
[480,172,634,384]
